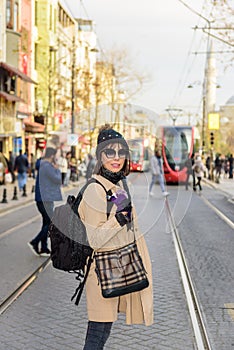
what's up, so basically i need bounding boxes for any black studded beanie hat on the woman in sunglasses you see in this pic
[96,129,129,158]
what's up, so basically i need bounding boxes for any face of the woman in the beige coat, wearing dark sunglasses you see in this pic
[101,143,128,173]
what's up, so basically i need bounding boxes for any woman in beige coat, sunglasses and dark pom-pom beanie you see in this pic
[78,126,153,350]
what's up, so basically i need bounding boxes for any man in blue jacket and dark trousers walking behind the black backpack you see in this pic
[28,147,62,256]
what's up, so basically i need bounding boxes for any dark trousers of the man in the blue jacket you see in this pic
[32,202,54,251]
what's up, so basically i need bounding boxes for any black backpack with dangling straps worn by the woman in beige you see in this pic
[48,178,112,305]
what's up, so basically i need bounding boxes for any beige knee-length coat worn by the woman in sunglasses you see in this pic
[78,175,153,326]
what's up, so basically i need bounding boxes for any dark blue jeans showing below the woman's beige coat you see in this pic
[83,321,112,350]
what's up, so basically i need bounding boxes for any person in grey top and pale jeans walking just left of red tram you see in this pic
[149,150,169,196]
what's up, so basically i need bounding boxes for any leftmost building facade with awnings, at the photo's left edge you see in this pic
[0,0,35,156]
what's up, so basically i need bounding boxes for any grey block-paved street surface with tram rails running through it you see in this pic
[0,174,234,350]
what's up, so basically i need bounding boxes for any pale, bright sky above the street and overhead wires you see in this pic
[64,0,234,123]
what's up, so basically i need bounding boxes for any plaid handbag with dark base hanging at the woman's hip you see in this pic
[94,240,149,298]
